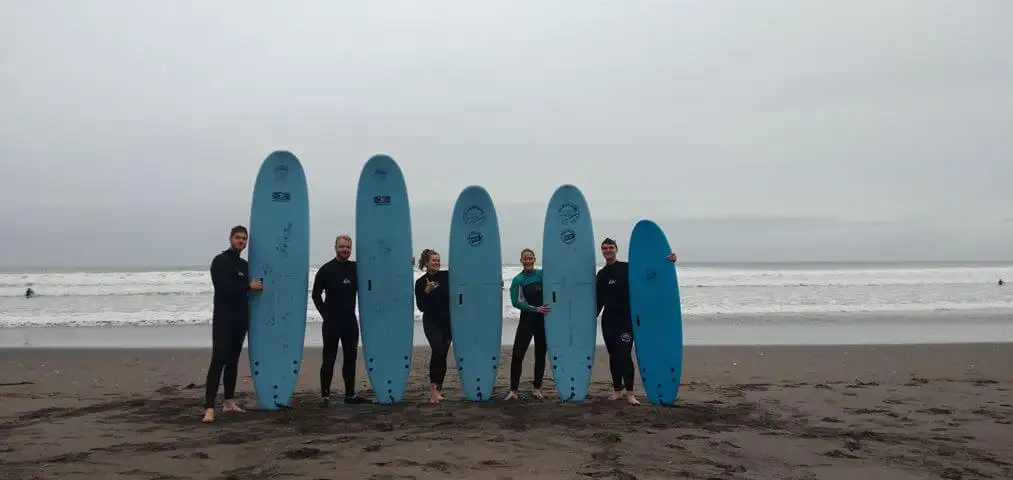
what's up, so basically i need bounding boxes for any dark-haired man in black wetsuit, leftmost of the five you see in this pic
[202,225,263,423]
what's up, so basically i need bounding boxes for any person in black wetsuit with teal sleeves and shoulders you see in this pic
[507,248,549,400]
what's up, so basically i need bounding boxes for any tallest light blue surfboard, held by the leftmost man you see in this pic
[249,151,310,410]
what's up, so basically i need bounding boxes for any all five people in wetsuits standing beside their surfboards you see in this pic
[203,226,677,423]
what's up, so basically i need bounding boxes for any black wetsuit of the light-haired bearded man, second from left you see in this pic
[312,258,359,399]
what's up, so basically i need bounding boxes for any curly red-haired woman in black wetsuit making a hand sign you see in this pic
[415,248,453,403]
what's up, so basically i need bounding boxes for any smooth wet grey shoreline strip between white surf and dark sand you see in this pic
[0,312,1013,349]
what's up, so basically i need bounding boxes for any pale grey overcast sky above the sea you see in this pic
[0,0,1013,266]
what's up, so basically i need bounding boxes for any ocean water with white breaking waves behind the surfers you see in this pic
[0,263,1013,343]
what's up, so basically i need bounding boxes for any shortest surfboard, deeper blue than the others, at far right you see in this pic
[628,220,683,405]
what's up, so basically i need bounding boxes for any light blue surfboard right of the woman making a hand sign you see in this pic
[450,185,503,402]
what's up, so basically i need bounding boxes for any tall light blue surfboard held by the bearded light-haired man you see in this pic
[356,155,415,404]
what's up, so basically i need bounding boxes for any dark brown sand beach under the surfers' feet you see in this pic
[0,344,1013,480]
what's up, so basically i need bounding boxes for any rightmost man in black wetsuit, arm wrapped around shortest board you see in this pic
[595,238,676,405]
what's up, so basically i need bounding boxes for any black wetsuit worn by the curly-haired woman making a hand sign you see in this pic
[415,270,453,390]
